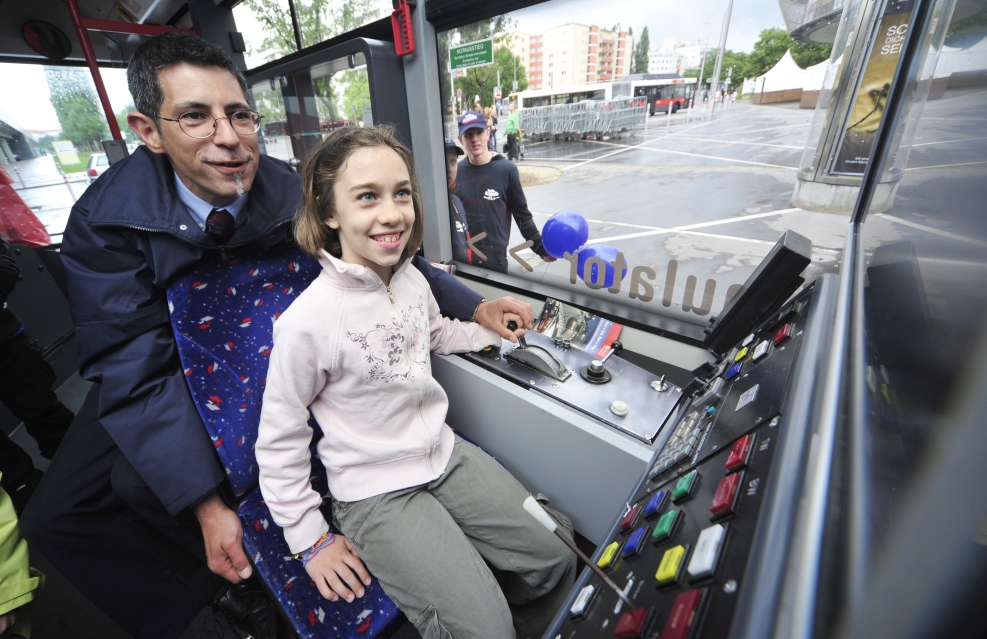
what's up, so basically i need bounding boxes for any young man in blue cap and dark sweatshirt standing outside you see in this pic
[456,111,555,273]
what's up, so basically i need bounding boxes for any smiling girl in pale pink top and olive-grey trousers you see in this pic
[256,127,575,639]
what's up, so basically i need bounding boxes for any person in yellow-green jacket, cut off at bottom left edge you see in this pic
[0,478,45,638]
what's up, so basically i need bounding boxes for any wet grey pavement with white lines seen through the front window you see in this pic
[498,102,850,324]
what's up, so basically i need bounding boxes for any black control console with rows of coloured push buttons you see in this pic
[545,285,818,639]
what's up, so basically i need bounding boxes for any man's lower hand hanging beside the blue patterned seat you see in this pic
[193,492,253,584]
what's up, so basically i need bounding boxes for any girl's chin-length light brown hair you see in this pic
[295,125,425,263]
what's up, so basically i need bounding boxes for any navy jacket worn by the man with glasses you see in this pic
[62,147,481,515]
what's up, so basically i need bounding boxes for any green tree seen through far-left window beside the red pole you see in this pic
[44,67,110,146]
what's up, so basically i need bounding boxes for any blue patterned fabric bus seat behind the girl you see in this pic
[168,248,403,639]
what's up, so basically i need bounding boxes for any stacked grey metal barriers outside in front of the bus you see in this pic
[521,98,648,140]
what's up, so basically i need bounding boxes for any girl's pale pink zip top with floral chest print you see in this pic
[256,251,500,553]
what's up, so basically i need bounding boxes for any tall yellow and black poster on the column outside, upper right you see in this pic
[830,0,914,175]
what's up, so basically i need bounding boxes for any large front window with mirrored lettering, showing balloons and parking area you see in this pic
[438,0,859,325]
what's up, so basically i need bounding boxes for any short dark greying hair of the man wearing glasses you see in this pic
[127,32,247,132]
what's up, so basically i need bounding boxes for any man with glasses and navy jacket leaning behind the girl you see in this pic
[22,33,533,639]
